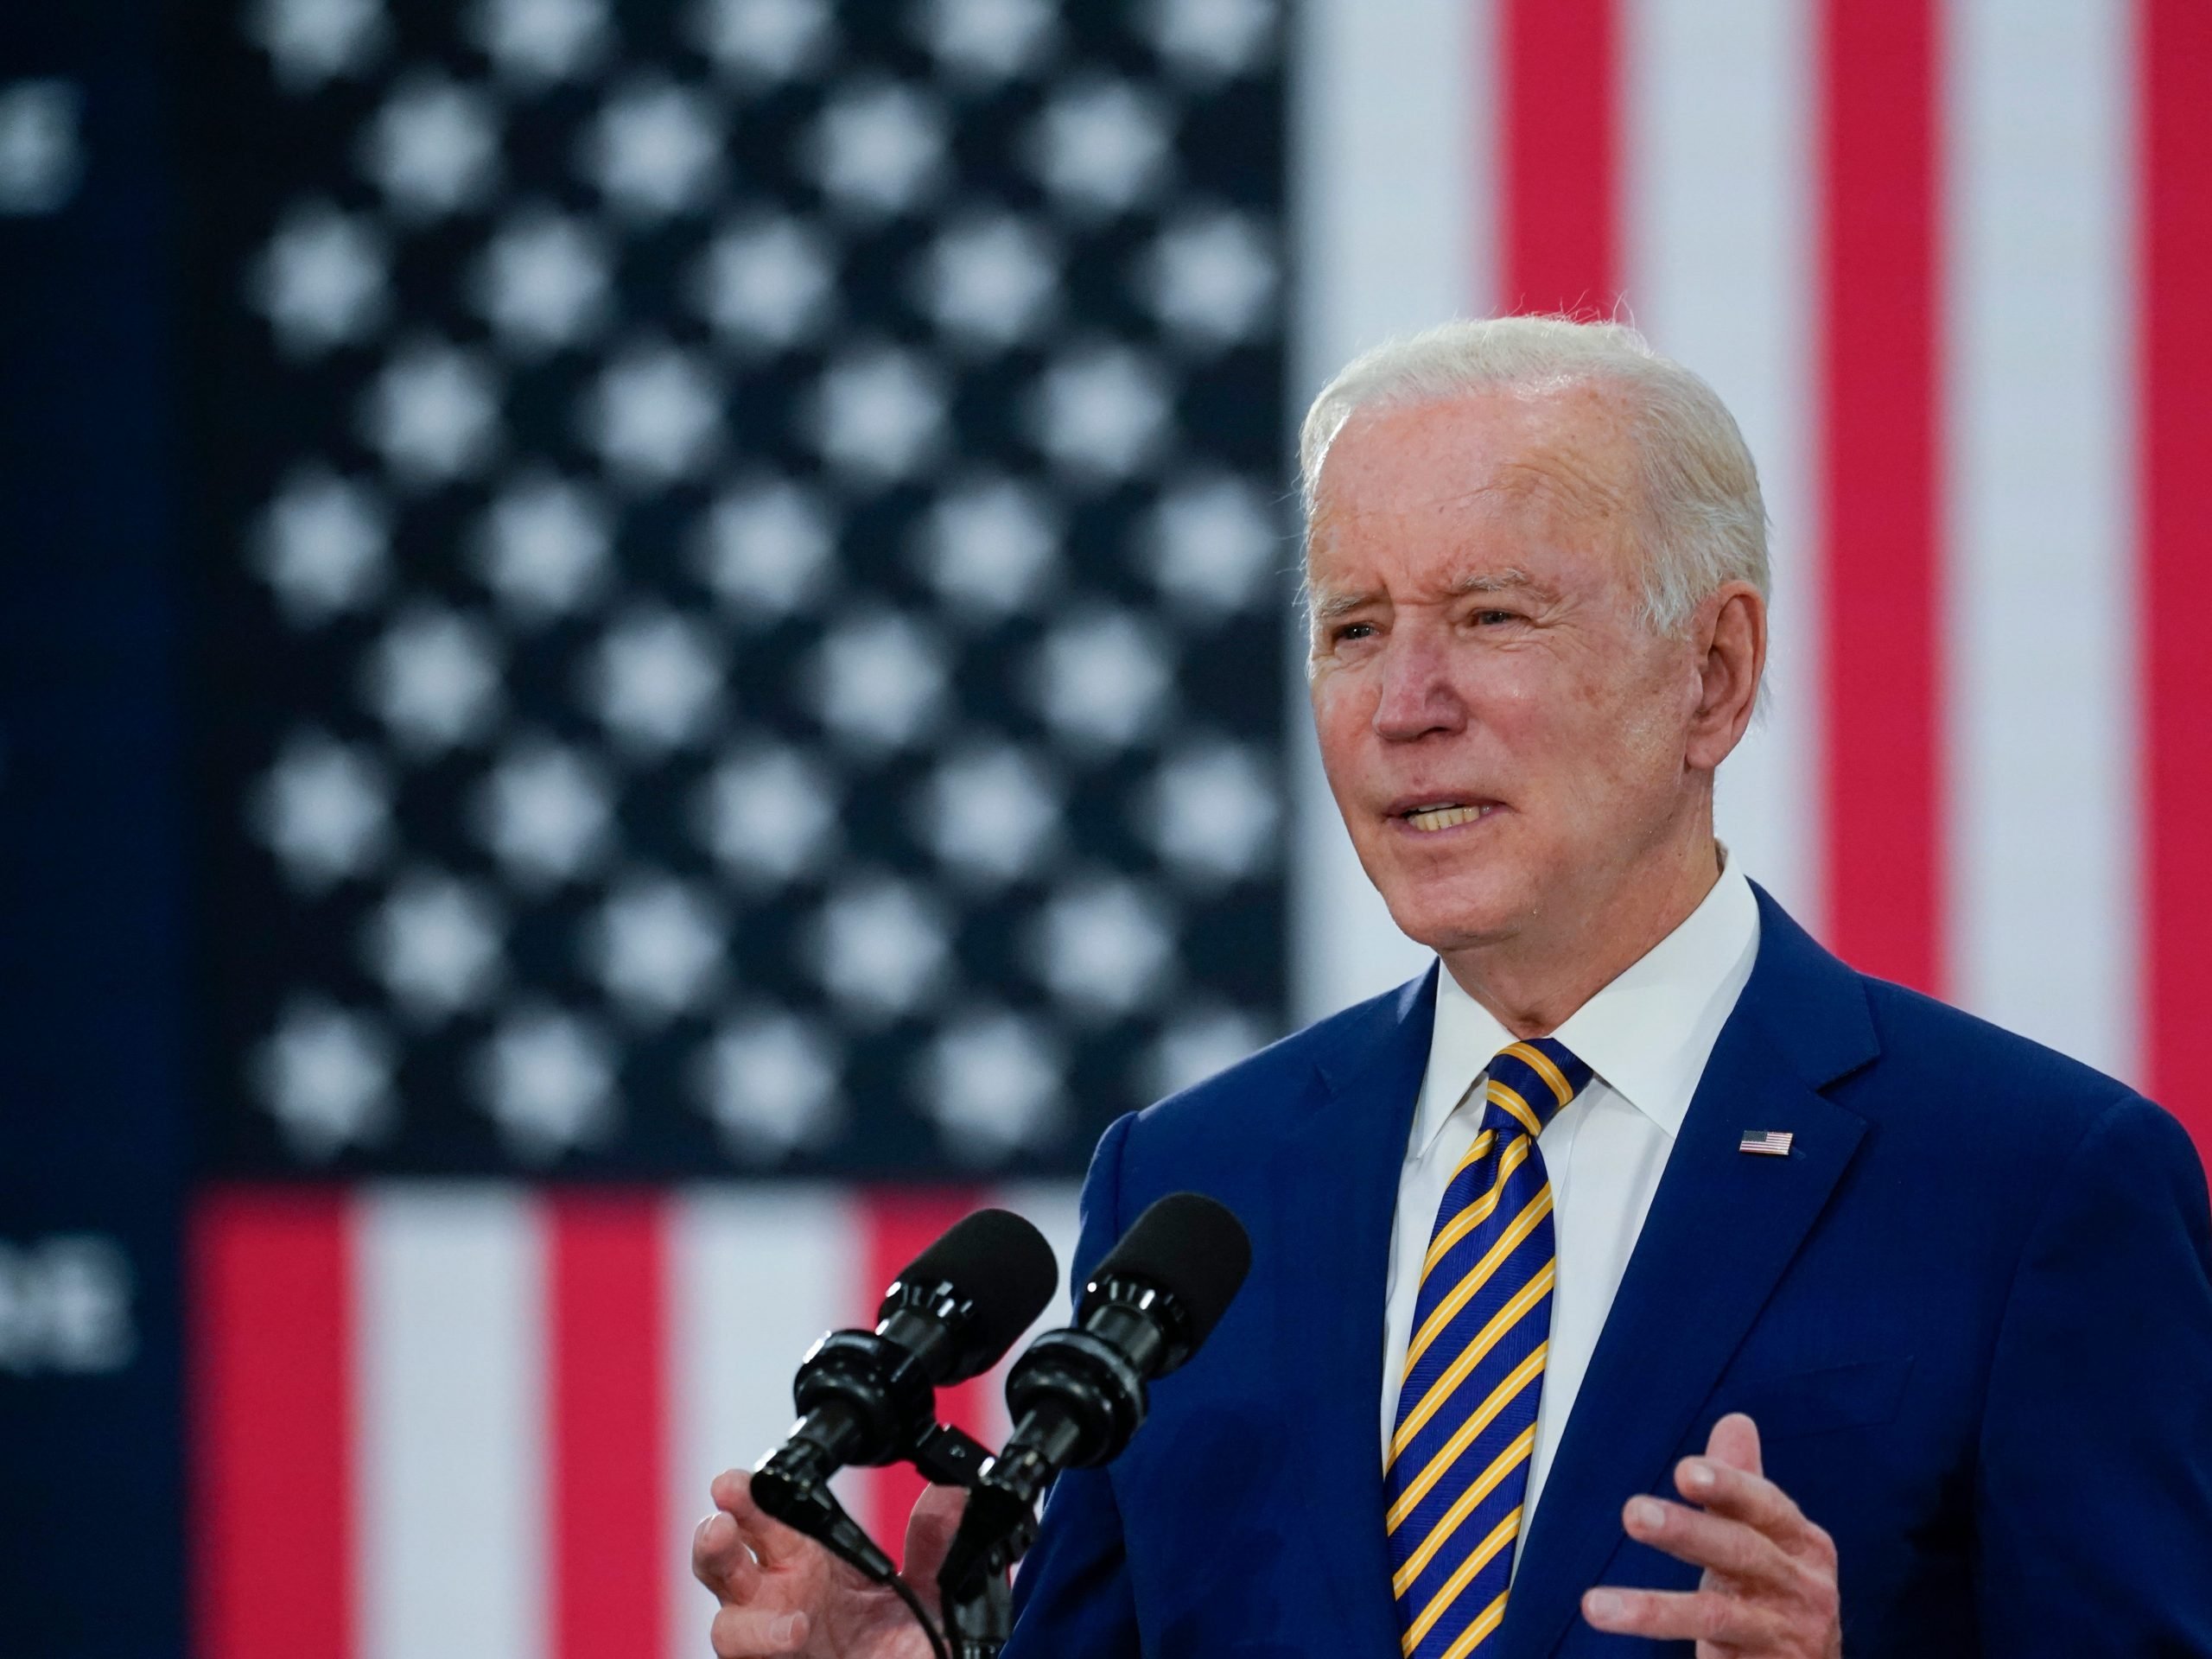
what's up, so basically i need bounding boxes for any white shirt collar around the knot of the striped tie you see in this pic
[1407,849,1758,1157]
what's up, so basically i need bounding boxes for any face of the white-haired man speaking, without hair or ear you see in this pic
[1310,385,1701,951]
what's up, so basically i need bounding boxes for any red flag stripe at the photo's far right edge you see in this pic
[2137,0,2212,1154]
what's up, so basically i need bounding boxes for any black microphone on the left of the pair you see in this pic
[752,1210,1059,1581]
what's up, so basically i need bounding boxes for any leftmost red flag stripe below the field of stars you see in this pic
[188,1192,356,1659]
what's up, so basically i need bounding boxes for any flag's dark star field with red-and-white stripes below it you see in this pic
[190,0,1296,1659]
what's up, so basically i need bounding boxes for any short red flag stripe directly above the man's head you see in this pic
[1497,0,1621,316]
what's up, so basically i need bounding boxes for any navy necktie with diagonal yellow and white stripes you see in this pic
[1382,1038,1591,1659]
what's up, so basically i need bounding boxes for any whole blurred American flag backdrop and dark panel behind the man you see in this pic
[0,0,2212,1659]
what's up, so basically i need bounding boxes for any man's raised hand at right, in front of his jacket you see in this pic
[1581,1411,1842,1659]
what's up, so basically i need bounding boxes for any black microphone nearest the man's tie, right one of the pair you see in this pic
[938,1192,1252,1606]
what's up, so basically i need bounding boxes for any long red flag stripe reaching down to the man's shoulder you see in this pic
[1821,0,1944,991]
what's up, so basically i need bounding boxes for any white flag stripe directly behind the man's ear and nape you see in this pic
[1621,0,1822,927]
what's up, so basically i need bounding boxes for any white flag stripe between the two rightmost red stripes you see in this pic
[1944,0,2139,1077]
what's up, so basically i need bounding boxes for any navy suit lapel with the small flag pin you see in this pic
[1500,893,1876,1659]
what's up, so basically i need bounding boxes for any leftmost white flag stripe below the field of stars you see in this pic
[358,1188,549,1659]
